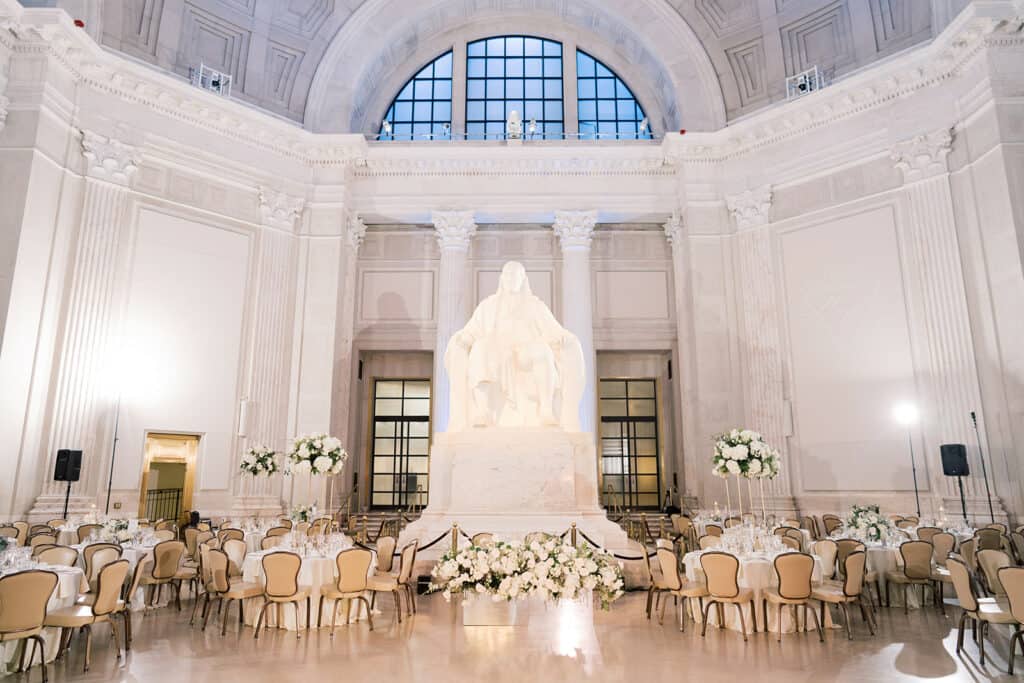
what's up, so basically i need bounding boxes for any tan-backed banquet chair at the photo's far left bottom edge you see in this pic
[0,569,57,683]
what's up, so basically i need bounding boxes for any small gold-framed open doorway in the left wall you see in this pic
[138,433,200,526]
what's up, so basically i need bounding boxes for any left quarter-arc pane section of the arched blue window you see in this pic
[378,52,452,140]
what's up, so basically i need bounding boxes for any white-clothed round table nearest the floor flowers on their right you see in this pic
[683,550,831,633]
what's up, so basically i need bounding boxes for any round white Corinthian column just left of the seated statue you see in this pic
[432,211,476,432]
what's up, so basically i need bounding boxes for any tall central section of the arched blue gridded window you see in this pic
[466,36,565,140]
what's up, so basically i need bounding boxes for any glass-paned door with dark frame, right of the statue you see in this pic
[600,379,662,509]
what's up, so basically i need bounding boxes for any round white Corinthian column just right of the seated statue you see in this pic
[552,211,597,435]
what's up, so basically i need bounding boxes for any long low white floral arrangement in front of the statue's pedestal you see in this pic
[430,537,624,609]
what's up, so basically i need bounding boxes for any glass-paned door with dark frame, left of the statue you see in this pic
[370,379,430,508]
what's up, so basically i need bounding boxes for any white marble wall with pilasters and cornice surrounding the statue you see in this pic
[0,0,1024,517]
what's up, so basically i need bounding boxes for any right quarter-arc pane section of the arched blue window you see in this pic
[577,50,651,139]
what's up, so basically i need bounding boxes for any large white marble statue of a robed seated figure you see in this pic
[444,261,584,432]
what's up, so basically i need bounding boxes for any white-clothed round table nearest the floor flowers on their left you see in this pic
[242,548,377,631]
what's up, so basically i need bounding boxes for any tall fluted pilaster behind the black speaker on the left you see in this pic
[33,131,138,514]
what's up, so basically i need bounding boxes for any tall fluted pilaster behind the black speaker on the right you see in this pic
[891,129,1005,516]
